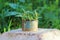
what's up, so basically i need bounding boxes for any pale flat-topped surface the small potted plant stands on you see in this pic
[0,28,60,40]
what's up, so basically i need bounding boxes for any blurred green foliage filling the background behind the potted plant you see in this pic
[0,0,60,33]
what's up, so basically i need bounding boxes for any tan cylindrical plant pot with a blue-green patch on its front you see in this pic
[22,20,38,31]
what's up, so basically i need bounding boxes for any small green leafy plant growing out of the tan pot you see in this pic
[16,10,39,20]
